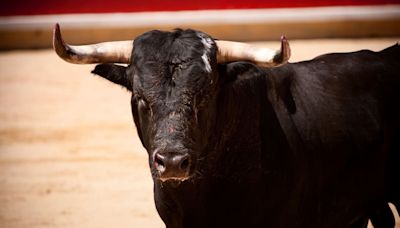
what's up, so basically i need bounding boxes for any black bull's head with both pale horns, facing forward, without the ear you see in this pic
[53,25,290,181]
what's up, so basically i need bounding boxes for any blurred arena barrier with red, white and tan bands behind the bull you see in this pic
[0,0,400,49]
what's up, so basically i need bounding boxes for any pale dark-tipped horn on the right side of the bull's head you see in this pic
[215,36,290,67]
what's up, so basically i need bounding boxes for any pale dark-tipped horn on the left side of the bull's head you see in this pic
[53,24,133,64]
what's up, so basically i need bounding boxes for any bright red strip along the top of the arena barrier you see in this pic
[0,0,400,16]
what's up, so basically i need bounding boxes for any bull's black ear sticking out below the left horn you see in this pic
[92,63,133,91]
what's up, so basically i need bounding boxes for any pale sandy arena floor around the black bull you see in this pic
[0,38,400,228]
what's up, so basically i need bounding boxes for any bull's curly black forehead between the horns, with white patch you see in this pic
[133,30,216,93]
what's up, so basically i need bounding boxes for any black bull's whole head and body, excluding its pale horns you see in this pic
[64,30,400,227]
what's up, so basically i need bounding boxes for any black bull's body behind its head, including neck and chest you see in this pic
[151,46,400,227]
